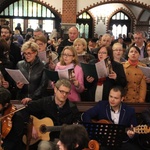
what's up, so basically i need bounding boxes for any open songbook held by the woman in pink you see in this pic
[45,68,75,82]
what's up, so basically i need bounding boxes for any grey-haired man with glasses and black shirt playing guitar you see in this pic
[23,79,80,150]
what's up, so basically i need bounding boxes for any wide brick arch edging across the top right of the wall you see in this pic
[77,0,150,16]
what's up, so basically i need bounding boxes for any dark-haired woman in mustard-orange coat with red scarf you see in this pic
[123,46,146,103]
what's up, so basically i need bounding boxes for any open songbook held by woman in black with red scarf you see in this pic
[81,57,113,79]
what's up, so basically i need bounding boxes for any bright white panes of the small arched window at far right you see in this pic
[110,11,131,38]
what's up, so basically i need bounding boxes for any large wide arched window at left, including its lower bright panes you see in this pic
[0,0,56,32]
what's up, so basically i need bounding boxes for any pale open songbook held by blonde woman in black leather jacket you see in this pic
[5,68,29,84]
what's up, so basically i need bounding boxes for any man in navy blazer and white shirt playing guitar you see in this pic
[82,86,142,150]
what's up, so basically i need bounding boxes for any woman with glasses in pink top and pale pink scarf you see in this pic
[55,46,84,102]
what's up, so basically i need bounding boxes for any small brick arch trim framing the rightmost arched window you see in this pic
[106,8,136,30]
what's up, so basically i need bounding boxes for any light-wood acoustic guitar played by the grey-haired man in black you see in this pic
[22,116,62,145]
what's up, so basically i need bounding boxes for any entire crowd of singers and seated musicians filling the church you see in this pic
[0,25,150,150]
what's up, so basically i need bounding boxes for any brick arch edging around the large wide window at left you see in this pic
[0,0,61,18]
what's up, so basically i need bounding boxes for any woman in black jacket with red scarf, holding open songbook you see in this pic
[86,46,127,101]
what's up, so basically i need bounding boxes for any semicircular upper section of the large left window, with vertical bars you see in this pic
[0,0,55,19]
